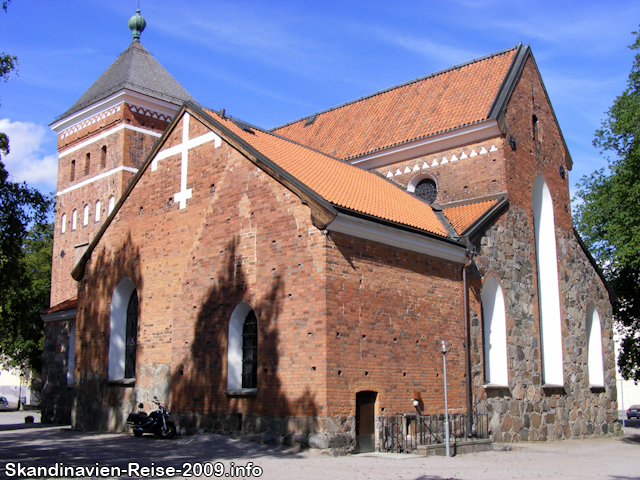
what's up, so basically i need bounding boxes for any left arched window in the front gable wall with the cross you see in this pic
[109,278,138,380]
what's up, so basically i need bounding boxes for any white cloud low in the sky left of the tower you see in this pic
[0,118,58,193]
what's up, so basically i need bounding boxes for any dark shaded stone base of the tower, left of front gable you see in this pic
[40,321,73,424]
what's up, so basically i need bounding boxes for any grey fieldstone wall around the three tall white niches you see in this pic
[470,205,620,442]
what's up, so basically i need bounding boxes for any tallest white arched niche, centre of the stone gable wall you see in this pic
[532,175,564,385]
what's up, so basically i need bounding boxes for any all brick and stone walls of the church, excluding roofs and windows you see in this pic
[41,42,619,450]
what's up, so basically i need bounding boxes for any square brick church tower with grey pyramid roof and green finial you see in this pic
[51,10,193,306]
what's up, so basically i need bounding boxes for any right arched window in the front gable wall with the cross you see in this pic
[227,302,258,391]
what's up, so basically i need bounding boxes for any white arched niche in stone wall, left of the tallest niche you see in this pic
[481,275,509,386]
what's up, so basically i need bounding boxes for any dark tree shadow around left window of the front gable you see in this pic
[72,234,144,430]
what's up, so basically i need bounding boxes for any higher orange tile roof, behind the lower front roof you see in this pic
[273,47,517,159]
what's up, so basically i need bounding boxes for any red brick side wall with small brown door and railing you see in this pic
[326,233,465,415]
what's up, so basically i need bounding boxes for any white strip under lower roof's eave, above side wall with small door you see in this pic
[327,213,469,264]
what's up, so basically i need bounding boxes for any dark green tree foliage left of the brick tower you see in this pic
[0,160,53,371]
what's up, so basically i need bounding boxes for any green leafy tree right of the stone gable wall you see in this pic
[574,32,640,382]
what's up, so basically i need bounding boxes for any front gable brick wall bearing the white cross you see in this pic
[77,114,326,422]
